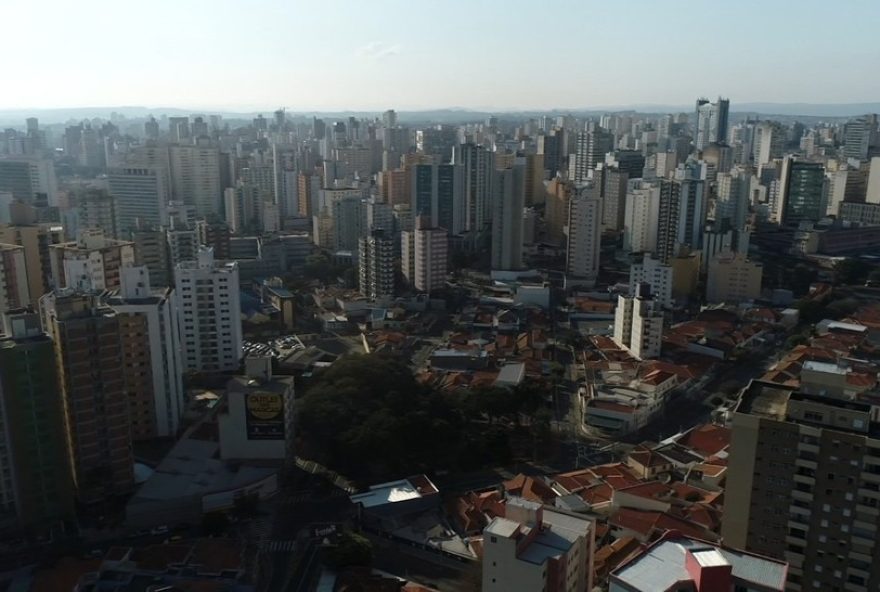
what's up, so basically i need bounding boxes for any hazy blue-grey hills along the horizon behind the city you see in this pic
[0,102,880,126]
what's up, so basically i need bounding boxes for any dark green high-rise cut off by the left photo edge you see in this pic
[0,310,75,527]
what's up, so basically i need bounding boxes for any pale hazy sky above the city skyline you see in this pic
[0,0,880,111]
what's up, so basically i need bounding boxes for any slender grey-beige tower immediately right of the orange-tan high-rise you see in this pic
[565,192,603,282]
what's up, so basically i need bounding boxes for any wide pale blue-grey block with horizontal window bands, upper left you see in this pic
[107,167,171,234]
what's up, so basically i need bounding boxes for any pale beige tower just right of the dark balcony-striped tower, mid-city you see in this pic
[400,217,449,293]
